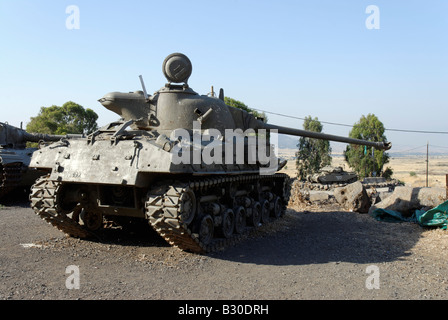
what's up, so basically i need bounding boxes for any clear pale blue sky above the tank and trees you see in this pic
[0,0,448,154]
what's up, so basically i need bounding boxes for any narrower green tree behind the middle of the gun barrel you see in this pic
[296,116,331,180]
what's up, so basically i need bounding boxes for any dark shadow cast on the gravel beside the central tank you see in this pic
[210,206,424,265]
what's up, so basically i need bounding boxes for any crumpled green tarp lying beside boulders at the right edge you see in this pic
[372,201,448,229]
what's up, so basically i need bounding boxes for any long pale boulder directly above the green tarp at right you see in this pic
[369,187,446,217]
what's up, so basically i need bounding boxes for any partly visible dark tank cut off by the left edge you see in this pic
[0,122,75,198]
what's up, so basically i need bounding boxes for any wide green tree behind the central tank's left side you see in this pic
[26,101,98,135]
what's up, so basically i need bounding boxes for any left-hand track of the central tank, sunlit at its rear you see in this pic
[30,176,97,238]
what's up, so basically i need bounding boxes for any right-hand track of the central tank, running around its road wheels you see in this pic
[145,174,289,253]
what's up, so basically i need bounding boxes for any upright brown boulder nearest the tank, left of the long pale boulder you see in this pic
[334,181,370,213]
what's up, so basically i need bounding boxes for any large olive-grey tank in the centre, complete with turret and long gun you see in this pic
[30,53,390,253]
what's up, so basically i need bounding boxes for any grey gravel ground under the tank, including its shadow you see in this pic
[0,192,448,300]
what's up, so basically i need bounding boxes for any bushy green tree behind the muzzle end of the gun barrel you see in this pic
[344,114,389,178]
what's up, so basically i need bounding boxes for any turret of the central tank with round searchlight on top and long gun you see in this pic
[99,53,391,150]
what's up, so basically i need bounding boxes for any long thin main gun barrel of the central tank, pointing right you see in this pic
[262,123,392,150]
